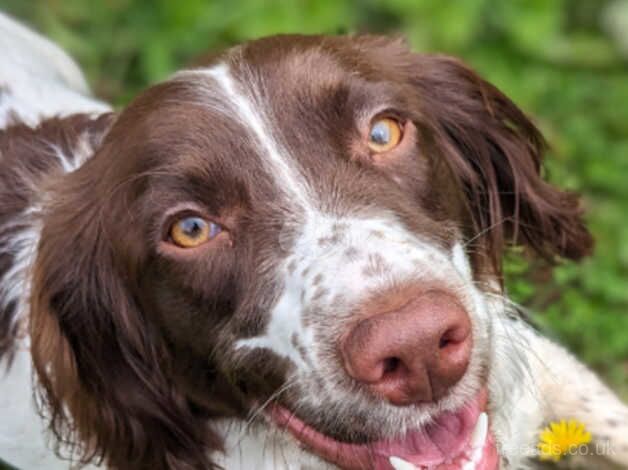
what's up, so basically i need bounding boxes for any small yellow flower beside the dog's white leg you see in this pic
[537,419,591,462]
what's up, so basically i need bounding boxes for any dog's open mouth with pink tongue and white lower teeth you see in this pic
[268,390,499,470]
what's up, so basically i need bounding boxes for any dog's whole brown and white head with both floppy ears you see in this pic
[31,37,590,469]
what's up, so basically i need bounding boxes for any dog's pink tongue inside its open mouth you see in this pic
[371,404,480,468]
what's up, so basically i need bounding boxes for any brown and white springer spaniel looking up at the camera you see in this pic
[0,11,628,470]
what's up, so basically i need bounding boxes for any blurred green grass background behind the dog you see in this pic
[0,0,628,397]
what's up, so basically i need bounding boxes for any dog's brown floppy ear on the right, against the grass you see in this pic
[413,55,593,273]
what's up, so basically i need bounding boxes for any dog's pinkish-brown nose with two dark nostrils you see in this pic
[341,292,472,406]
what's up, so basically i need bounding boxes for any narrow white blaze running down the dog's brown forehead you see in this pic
[185,64,313,211]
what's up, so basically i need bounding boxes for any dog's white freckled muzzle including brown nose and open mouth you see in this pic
[238,216,490,470]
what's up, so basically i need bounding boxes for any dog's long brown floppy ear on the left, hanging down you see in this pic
[30,123,221,470]
